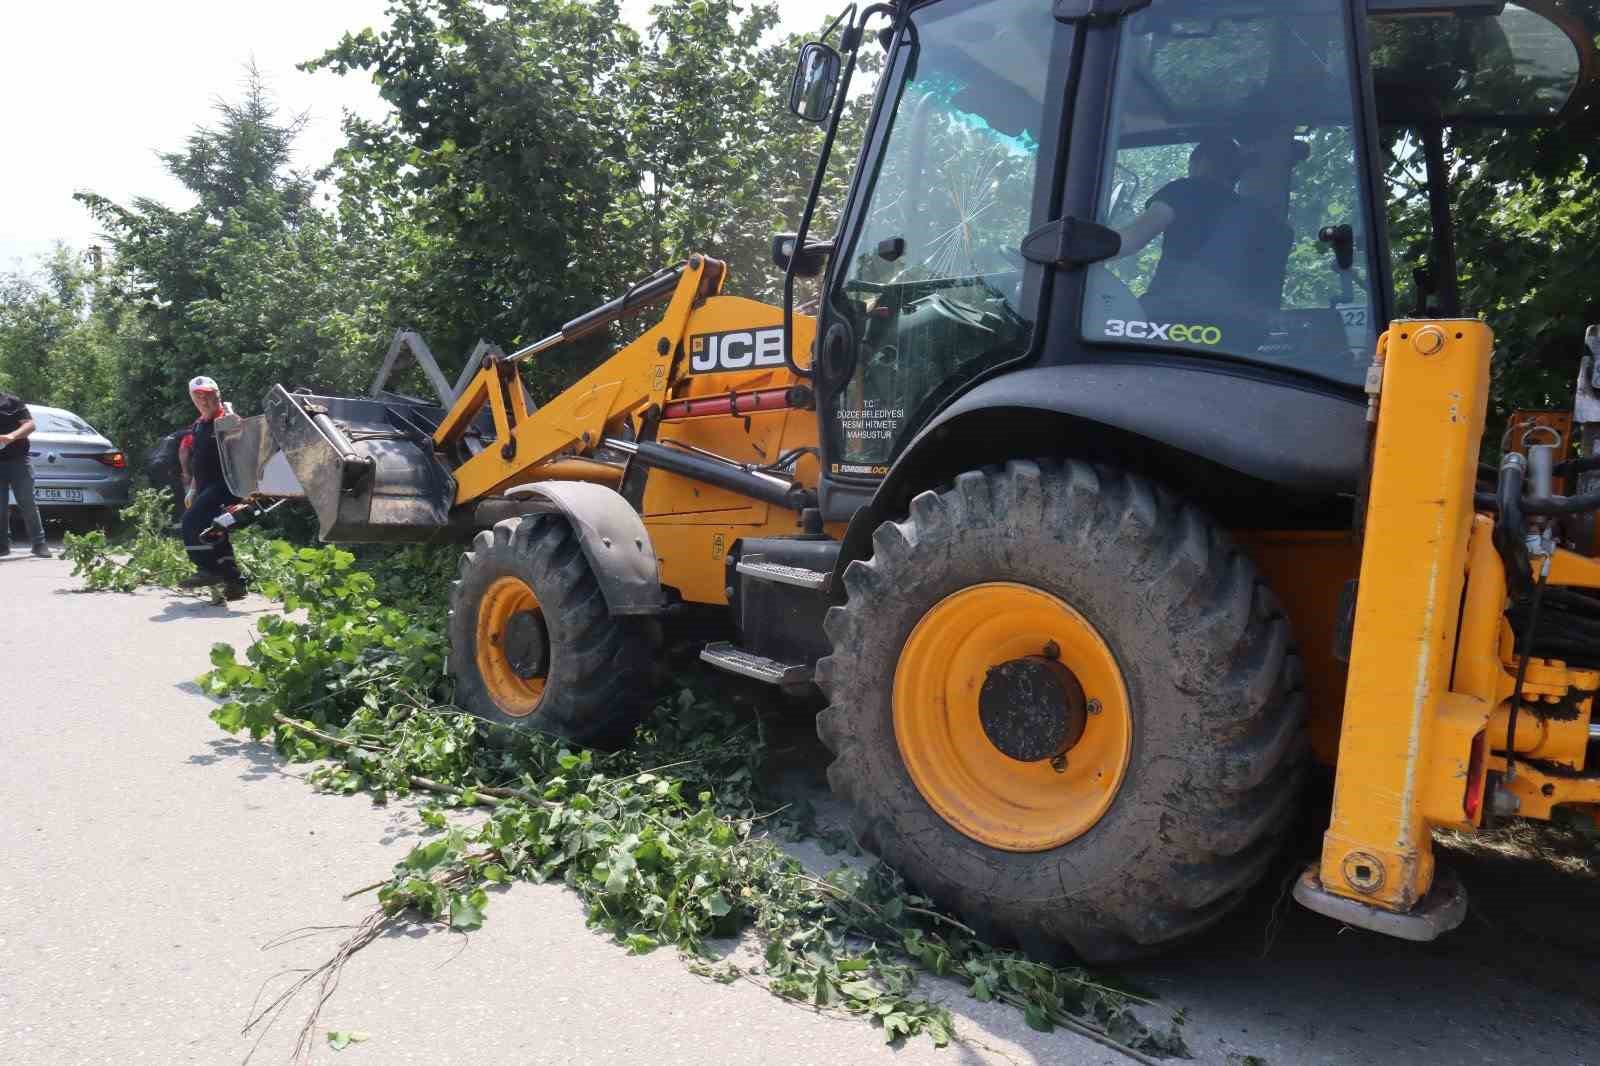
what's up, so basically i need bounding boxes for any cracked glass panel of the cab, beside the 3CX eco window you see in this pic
[830,0,1067,474]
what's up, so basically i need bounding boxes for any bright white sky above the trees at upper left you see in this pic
[0,0,819,272]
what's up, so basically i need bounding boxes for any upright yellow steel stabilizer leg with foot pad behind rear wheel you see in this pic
[1294,320,1494,940]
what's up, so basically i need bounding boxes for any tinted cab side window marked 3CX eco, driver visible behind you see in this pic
[1083,0,1376,384]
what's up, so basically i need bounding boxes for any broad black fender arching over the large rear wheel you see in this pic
[830,363,1366,585]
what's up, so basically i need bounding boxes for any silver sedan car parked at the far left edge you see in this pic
[6,403,130,523]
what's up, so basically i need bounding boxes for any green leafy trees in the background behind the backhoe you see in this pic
[0,0,1600,459]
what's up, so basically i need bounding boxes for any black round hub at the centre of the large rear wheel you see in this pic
[978,655,1088,762]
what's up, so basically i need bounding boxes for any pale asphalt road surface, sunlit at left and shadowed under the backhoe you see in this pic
[0,554,1600,1066]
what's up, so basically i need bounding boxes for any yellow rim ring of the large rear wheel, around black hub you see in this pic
[893,583,1133,852]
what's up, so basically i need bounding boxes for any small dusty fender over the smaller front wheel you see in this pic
[492,482,666,615]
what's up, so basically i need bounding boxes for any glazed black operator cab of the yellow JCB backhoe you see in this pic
[797,0,1592,498]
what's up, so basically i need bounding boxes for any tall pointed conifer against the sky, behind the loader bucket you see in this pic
[78,67,400,451]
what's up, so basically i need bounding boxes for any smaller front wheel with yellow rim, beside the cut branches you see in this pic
[450,514,656,749]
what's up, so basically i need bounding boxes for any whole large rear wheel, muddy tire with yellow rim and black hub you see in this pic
[818,463,1306,960]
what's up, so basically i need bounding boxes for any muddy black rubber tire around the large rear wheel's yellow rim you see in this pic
[818,463,1307,960]
